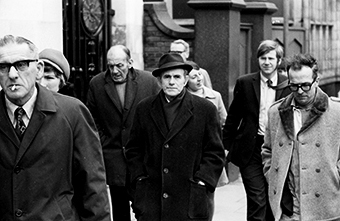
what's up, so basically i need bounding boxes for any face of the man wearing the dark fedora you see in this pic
[159,68,188,100]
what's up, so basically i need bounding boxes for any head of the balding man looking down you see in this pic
[107,48,132,82]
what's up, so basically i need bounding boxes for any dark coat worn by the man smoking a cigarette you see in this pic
[0,85,110,221]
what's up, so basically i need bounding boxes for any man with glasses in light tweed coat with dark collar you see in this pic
[262,54,340,221]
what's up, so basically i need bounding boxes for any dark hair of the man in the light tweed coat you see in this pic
[286,54,319,79]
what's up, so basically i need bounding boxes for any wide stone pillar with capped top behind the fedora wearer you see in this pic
[188,0,246,108]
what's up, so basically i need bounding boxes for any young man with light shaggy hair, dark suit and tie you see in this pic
[223,40,290,221]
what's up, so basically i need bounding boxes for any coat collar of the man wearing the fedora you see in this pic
[151,89,195,142]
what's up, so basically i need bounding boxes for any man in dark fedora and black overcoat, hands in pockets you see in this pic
[125,53,225,221]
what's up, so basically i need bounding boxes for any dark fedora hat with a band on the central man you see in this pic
[152,53,192,77]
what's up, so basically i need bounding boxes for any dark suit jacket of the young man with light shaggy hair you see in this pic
[223,72,290,167]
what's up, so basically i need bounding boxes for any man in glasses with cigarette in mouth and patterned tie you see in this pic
[0,35,110,221]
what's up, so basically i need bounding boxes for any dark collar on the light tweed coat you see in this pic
[278,88,328,139]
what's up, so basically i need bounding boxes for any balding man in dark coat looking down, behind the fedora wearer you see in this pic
[87,45,160,221]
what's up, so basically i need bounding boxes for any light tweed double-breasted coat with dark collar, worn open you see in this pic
[262,89,340,221]
